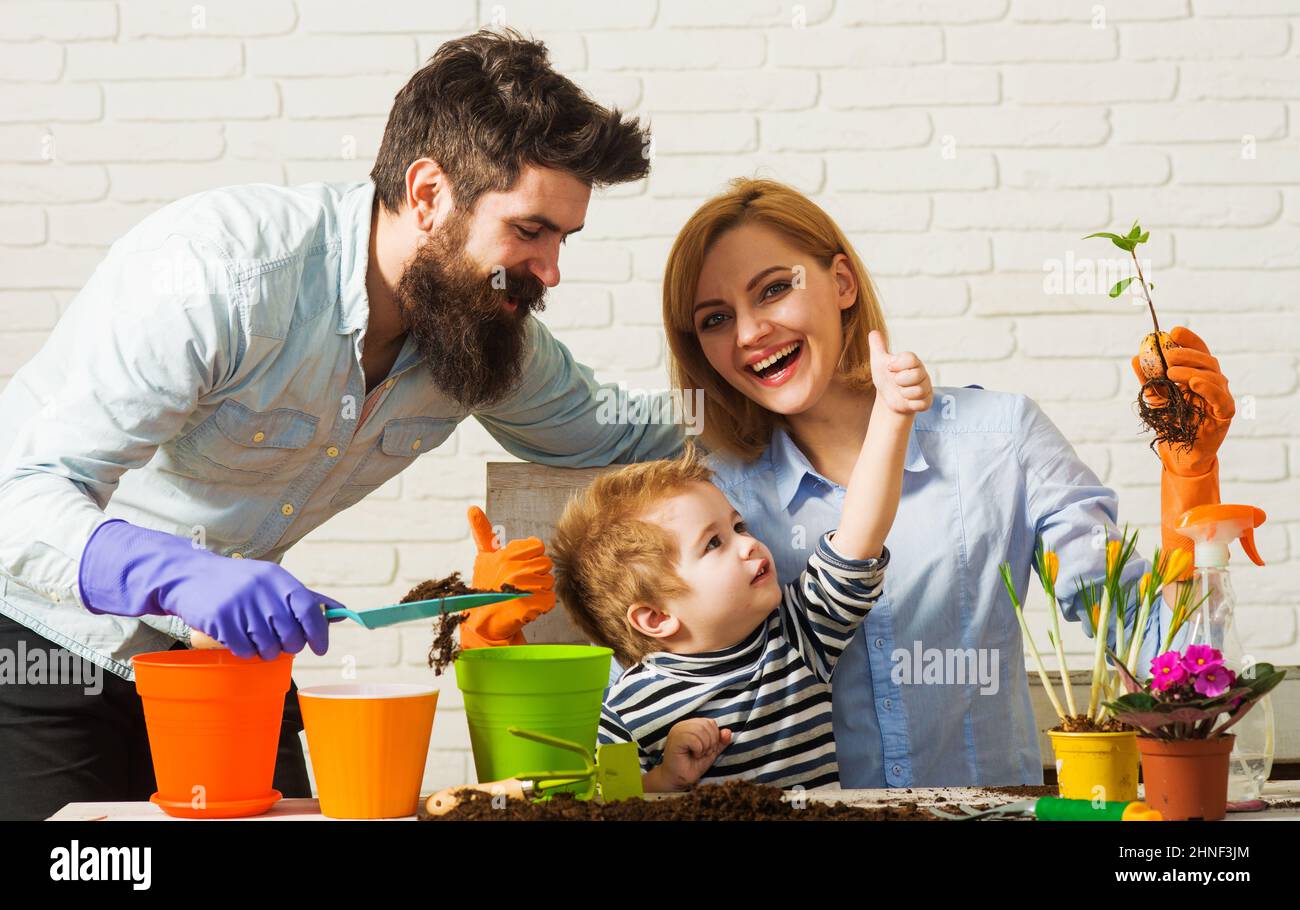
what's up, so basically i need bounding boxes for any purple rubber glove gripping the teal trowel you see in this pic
[77,519,342,660]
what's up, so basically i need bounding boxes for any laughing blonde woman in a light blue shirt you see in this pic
[663,179,1147,788]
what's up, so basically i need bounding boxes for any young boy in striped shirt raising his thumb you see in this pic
[553,332,931,792]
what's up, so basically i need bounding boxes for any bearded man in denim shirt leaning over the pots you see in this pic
[0,31,681,818]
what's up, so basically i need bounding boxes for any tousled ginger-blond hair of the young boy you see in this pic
[550,442,714,667]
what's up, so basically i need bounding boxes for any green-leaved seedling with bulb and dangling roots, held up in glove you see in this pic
[1083,221,1205,451]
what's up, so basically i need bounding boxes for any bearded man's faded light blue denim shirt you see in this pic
[0,181,683,679]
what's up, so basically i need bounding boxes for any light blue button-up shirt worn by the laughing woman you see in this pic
[711,387,1158,788]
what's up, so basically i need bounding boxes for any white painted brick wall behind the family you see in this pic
[0,0,1300,787]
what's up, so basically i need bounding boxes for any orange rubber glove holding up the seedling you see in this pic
[1132,325,1236,579]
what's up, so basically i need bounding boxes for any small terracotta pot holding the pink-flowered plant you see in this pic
[1138,733,1236,822]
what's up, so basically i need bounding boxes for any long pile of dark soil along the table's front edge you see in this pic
[420,780,956,822]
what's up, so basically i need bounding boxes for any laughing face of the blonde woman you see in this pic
[693,224,858,415]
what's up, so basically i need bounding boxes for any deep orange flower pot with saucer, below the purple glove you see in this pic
[131,650,294,818]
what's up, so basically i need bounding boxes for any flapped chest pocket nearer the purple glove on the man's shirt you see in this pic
[176,398,319,481]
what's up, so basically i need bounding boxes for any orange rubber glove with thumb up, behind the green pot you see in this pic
[460,506,555,647]
